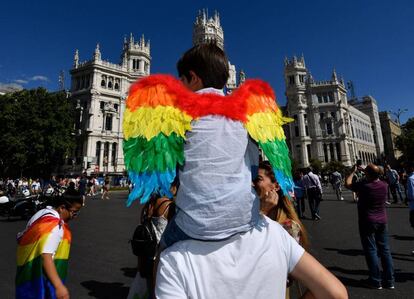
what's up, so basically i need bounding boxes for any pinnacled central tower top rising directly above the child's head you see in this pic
[193,9,224,50]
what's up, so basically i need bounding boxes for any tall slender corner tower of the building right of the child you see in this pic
[284,56,312,166]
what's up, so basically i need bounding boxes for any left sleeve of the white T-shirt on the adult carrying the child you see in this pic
[155,254,187,299]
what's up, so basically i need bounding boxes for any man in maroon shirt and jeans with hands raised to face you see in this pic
[345,164,395,289]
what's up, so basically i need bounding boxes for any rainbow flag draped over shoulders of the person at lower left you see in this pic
[16,215,72,299]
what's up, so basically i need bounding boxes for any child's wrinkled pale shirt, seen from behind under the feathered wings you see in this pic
[175,88,259,240]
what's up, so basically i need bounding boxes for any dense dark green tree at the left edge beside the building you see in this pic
[0,88,75,177]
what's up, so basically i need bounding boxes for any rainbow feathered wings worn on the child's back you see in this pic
[123,75,293,206]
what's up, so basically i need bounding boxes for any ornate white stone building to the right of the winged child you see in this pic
[284,56,384,167]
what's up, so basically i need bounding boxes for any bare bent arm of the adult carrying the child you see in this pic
[290,252,348,299]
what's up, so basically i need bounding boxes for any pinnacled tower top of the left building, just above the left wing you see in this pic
[122,33,151,77]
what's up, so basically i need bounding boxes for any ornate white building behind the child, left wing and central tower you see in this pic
[69,11,245,175]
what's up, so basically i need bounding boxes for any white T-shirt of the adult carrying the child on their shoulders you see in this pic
[155,216,304,299]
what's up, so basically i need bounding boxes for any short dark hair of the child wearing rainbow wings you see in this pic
[177,42,229,89]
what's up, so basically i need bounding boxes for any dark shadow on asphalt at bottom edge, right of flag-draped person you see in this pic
[81,280,129,299]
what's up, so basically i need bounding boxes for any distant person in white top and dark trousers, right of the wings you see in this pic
[303,167,322,220]
